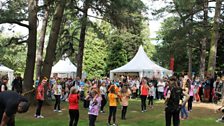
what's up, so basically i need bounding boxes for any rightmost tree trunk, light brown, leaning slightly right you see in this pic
[208,0,222,77]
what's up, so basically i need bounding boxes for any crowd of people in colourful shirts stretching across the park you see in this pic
[1,75,224,126]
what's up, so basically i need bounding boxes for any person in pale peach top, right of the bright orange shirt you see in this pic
[121,84,131,120]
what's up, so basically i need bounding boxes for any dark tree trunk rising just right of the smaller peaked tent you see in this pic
[76,0,89,78]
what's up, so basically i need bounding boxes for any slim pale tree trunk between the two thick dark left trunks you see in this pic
[36,3,49,79]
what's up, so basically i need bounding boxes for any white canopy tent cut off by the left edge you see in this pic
[0,64,14,87]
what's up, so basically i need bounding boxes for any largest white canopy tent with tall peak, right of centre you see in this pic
[110,45,172,79]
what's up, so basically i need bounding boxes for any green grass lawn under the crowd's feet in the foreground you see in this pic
[16,100,224,126]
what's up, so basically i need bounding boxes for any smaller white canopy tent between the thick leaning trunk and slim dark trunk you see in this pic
[51,57,77,78]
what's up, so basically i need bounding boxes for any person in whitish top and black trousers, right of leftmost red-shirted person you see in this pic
[53,80,62,112]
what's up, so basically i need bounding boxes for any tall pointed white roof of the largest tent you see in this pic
[110,45,171,73]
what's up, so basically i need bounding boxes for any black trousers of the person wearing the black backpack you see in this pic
[165,108,180,126]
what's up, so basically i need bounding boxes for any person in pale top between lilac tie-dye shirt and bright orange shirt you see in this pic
[100,82,107,113]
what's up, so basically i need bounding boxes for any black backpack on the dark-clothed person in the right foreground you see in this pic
[166,88,183,112]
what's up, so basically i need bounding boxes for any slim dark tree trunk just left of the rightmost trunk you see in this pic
[199,0,208,79]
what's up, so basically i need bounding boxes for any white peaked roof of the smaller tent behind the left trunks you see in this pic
[51,57,77,73]
